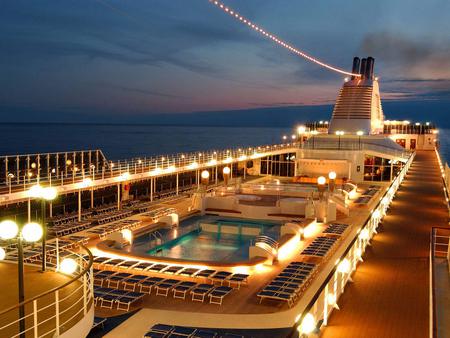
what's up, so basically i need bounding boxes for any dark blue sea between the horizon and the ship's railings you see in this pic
[0,123,450,162]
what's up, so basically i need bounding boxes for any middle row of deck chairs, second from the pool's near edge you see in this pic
[94,270,233,305]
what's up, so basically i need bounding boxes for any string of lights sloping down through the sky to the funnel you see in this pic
[209,0,361,77]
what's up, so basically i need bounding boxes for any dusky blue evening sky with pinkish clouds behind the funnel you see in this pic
[0,0,450,122]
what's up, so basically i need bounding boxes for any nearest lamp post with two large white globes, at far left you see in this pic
[0,220,44,338]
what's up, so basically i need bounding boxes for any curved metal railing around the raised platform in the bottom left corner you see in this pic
[0,244,94,338]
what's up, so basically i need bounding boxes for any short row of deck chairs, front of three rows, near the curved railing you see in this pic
[94,286,144,311]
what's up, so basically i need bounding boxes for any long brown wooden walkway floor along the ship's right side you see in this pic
[321,152,448,338]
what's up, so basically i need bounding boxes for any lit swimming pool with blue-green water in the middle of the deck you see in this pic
[130,216,281,263]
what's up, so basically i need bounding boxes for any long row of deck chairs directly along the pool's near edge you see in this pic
[94,256,249,289]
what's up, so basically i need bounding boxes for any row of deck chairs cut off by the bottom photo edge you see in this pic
[144,324,244,338]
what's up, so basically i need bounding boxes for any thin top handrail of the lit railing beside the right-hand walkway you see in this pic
[287,152,416,338]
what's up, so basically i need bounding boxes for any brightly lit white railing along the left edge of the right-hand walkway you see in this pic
[288,153,415,338]
